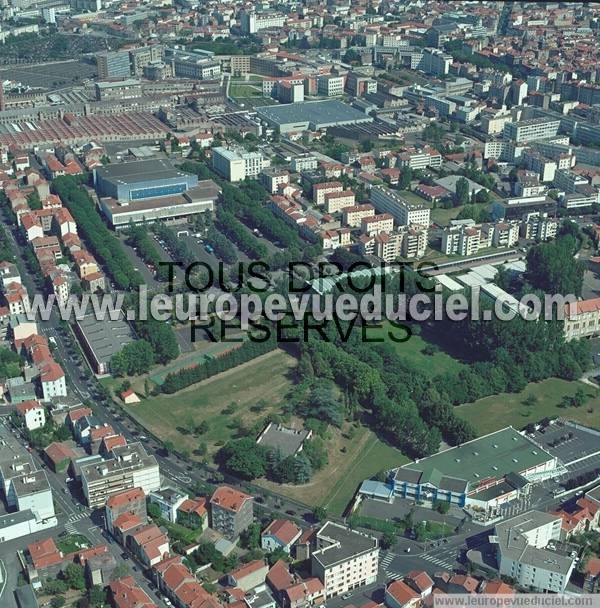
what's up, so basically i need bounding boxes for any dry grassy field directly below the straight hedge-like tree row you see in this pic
[123,350,296,454]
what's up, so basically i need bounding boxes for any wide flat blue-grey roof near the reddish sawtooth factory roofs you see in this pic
[255,99,373,126]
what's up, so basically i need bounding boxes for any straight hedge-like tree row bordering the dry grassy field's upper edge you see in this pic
[161,332,277,394]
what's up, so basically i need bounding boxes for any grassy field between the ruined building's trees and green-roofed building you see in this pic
[259,424,408,515]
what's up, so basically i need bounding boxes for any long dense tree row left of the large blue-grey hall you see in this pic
[52,175,142,289]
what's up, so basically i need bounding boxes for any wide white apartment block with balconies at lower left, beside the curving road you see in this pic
[81,443,160,507]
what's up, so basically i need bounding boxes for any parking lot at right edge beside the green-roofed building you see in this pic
[532,421,600,467]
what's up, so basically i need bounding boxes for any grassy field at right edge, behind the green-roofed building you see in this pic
[455,378,600,435]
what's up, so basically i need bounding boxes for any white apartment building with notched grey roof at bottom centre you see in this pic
[311,522,379,598]
